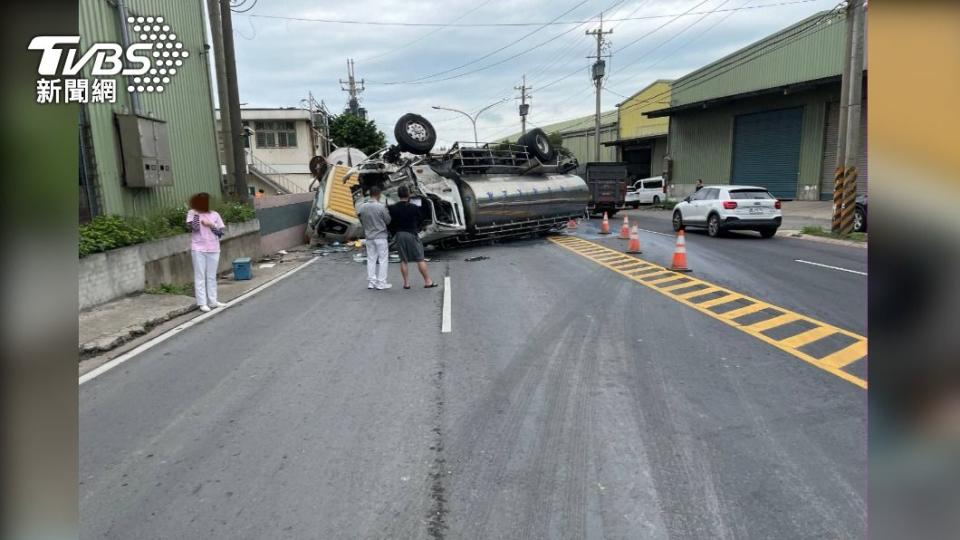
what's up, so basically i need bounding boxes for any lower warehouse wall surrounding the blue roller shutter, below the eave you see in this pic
[670,84,840,200]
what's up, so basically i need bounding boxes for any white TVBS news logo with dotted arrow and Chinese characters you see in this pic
[27,17,190,103]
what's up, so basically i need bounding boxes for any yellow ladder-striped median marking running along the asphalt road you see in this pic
[550,236,868,389]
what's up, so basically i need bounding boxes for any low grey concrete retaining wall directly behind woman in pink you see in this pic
[79,220,260,309]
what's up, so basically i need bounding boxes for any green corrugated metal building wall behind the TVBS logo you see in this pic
[79,0,220,216]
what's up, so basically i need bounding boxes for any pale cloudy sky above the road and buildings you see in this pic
[221,0,838,147]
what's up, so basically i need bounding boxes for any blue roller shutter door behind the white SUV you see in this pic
[730,107,803,199]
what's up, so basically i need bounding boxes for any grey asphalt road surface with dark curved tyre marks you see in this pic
[80,225,867,539]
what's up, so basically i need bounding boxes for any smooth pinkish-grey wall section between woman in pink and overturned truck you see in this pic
[253,192,316,253]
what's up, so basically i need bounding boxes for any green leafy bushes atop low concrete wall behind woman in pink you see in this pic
[79,202,256,257]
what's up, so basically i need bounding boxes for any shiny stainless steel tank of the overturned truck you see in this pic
[460,174,590,230]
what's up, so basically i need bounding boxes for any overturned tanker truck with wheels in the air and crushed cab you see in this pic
[308,114,589,248]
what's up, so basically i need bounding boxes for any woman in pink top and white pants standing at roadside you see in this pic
[187,193,225,311]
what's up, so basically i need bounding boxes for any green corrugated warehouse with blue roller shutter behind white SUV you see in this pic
[644,12,867,200]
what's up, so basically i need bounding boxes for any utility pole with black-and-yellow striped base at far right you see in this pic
[831,0,865,234]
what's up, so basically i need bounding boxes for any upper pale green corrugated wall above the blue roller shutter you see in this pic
[671,12,846,107]
